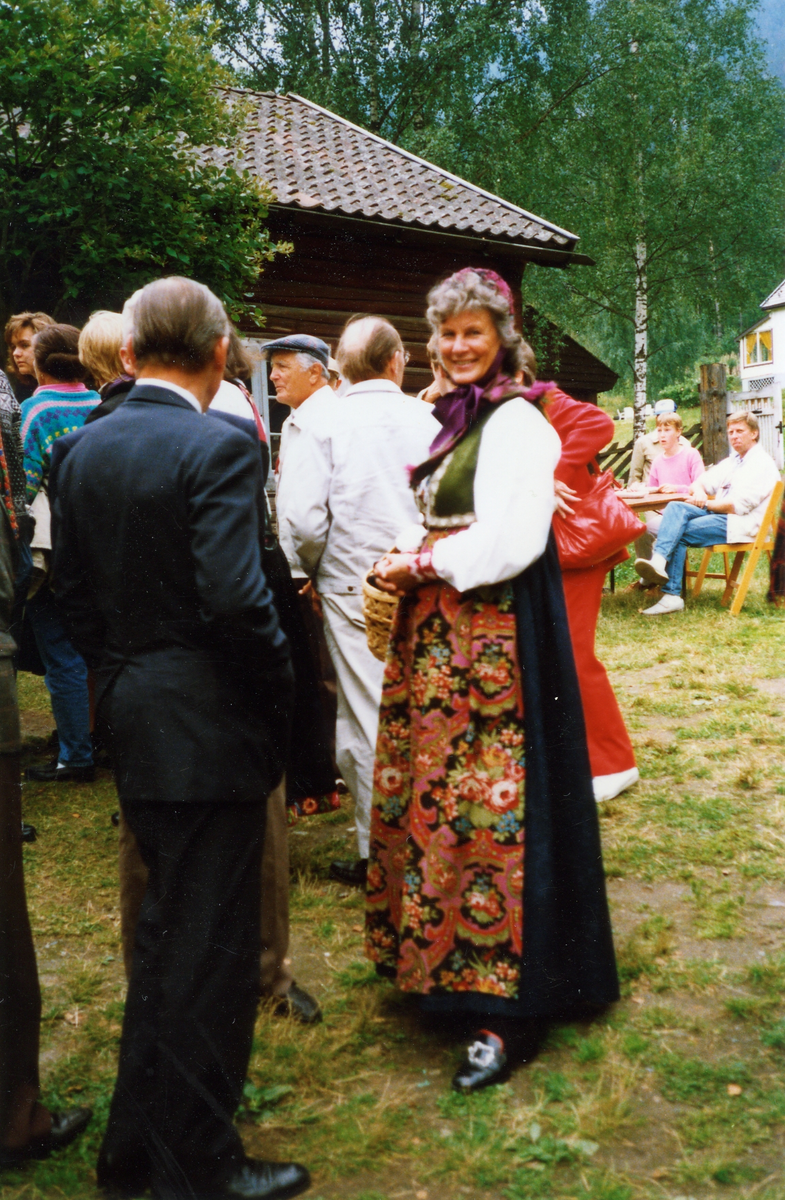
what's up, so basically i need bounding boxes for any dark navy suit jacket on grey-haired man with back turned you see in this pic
[53,383,293,803]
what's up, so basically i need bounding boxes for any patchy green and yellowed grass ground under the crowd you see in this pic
[0,568,785,1200]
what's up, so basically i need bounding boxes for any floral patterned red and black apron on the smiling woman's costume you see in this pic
[366,556,525,1000]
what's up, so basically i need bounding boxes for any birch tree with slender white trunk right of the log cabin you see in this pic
[507,0,785,433]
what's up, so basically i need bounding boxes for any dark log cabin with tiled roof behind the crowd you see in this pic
[206,89,618,430]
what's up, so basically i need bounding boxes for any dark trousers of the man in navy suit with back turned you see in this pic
[98,799,264,1200]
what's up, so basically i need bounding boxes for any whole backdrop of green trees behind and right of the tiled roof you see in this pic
[201,0,785,407]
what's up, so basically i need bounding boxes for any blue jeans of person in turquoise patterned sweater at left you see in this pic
[28,584,92,767]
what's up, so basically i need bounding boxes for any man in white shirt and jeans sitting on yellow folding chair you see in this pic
[635,413,779,617]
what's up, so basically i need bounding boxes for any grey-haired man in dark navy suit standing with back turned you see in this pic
[54,278,310,1200]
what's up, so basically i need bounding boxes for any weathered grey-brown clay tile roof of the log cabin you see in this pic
[209,88,577,252]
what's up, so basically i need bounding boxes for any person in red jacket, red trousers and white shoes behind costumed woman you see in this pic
[547,388,639,802]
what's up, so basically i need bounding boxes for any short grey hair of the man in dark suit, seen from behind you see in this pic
[122,275,230,371]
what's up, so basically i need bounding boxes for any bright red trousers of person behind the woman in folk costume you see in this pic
[562,563,635,775]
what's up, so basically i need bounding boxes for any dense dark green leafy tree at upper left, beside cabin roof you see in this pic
[0,0,283,316]
